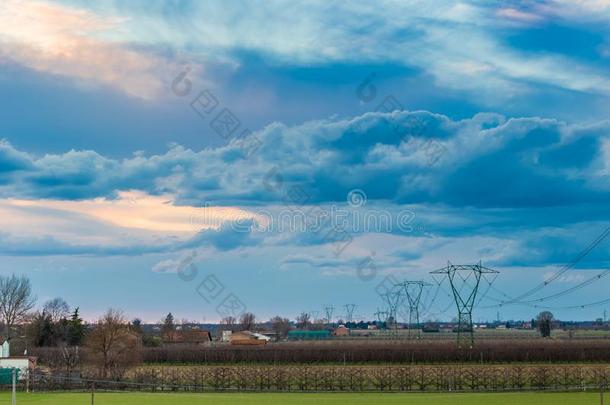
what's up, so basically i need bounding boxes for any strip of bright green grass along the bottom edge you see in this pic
[0,392,610,405]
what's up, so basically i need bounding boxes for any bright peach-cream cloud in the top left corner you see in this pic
[0,0,185,99]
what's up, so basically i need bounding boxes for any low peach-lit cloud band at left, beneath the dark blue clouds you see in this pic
[0,192,262,256]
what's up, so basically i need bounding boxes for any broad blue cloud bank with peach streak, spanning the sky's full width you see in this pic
[0,111,610,258]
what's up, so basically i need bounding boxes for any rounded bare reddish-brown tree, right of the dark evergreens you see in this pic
[86,309,140,379]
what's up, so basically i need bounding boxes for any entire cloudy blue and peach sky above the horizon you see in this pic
[0,0,610,322]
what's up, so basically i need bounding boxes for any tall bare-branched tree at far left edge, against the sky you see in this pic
[0,274,36,340]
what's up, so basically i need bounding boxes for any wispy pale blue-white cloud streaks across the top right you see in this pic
[70,0,610,105]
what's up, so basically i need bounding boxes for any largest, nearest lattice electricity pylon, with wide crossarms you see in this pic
[430,262,499,347]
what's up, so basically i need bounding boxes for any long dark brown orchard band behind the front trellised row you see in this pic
[33,339,610,366]
